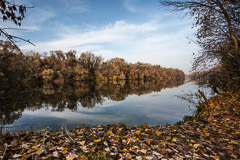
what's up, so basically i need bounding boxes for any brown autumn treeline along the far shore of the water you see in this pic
[0,41,185,84]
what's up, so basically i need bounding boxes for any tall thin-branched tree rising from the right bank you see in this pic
[160,0,240,90]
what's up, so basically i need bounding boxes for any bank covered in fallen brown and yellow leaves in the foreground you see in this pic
[0,92,240,160]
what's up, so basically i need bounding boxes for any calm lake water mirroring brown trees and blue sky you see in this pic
[0,81,198,132]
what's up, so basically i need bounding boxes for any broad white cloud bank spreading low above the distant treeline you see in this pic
[21,19,197,72]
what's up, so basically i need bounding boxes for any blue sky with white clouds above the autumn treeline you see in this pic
[1,0,198,73]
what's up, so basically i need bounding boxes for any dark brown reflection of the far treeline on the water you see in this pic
[0,79,183,125]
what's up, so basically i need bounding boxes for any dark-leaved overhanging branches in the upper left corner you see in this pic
[0,0,34,49]
